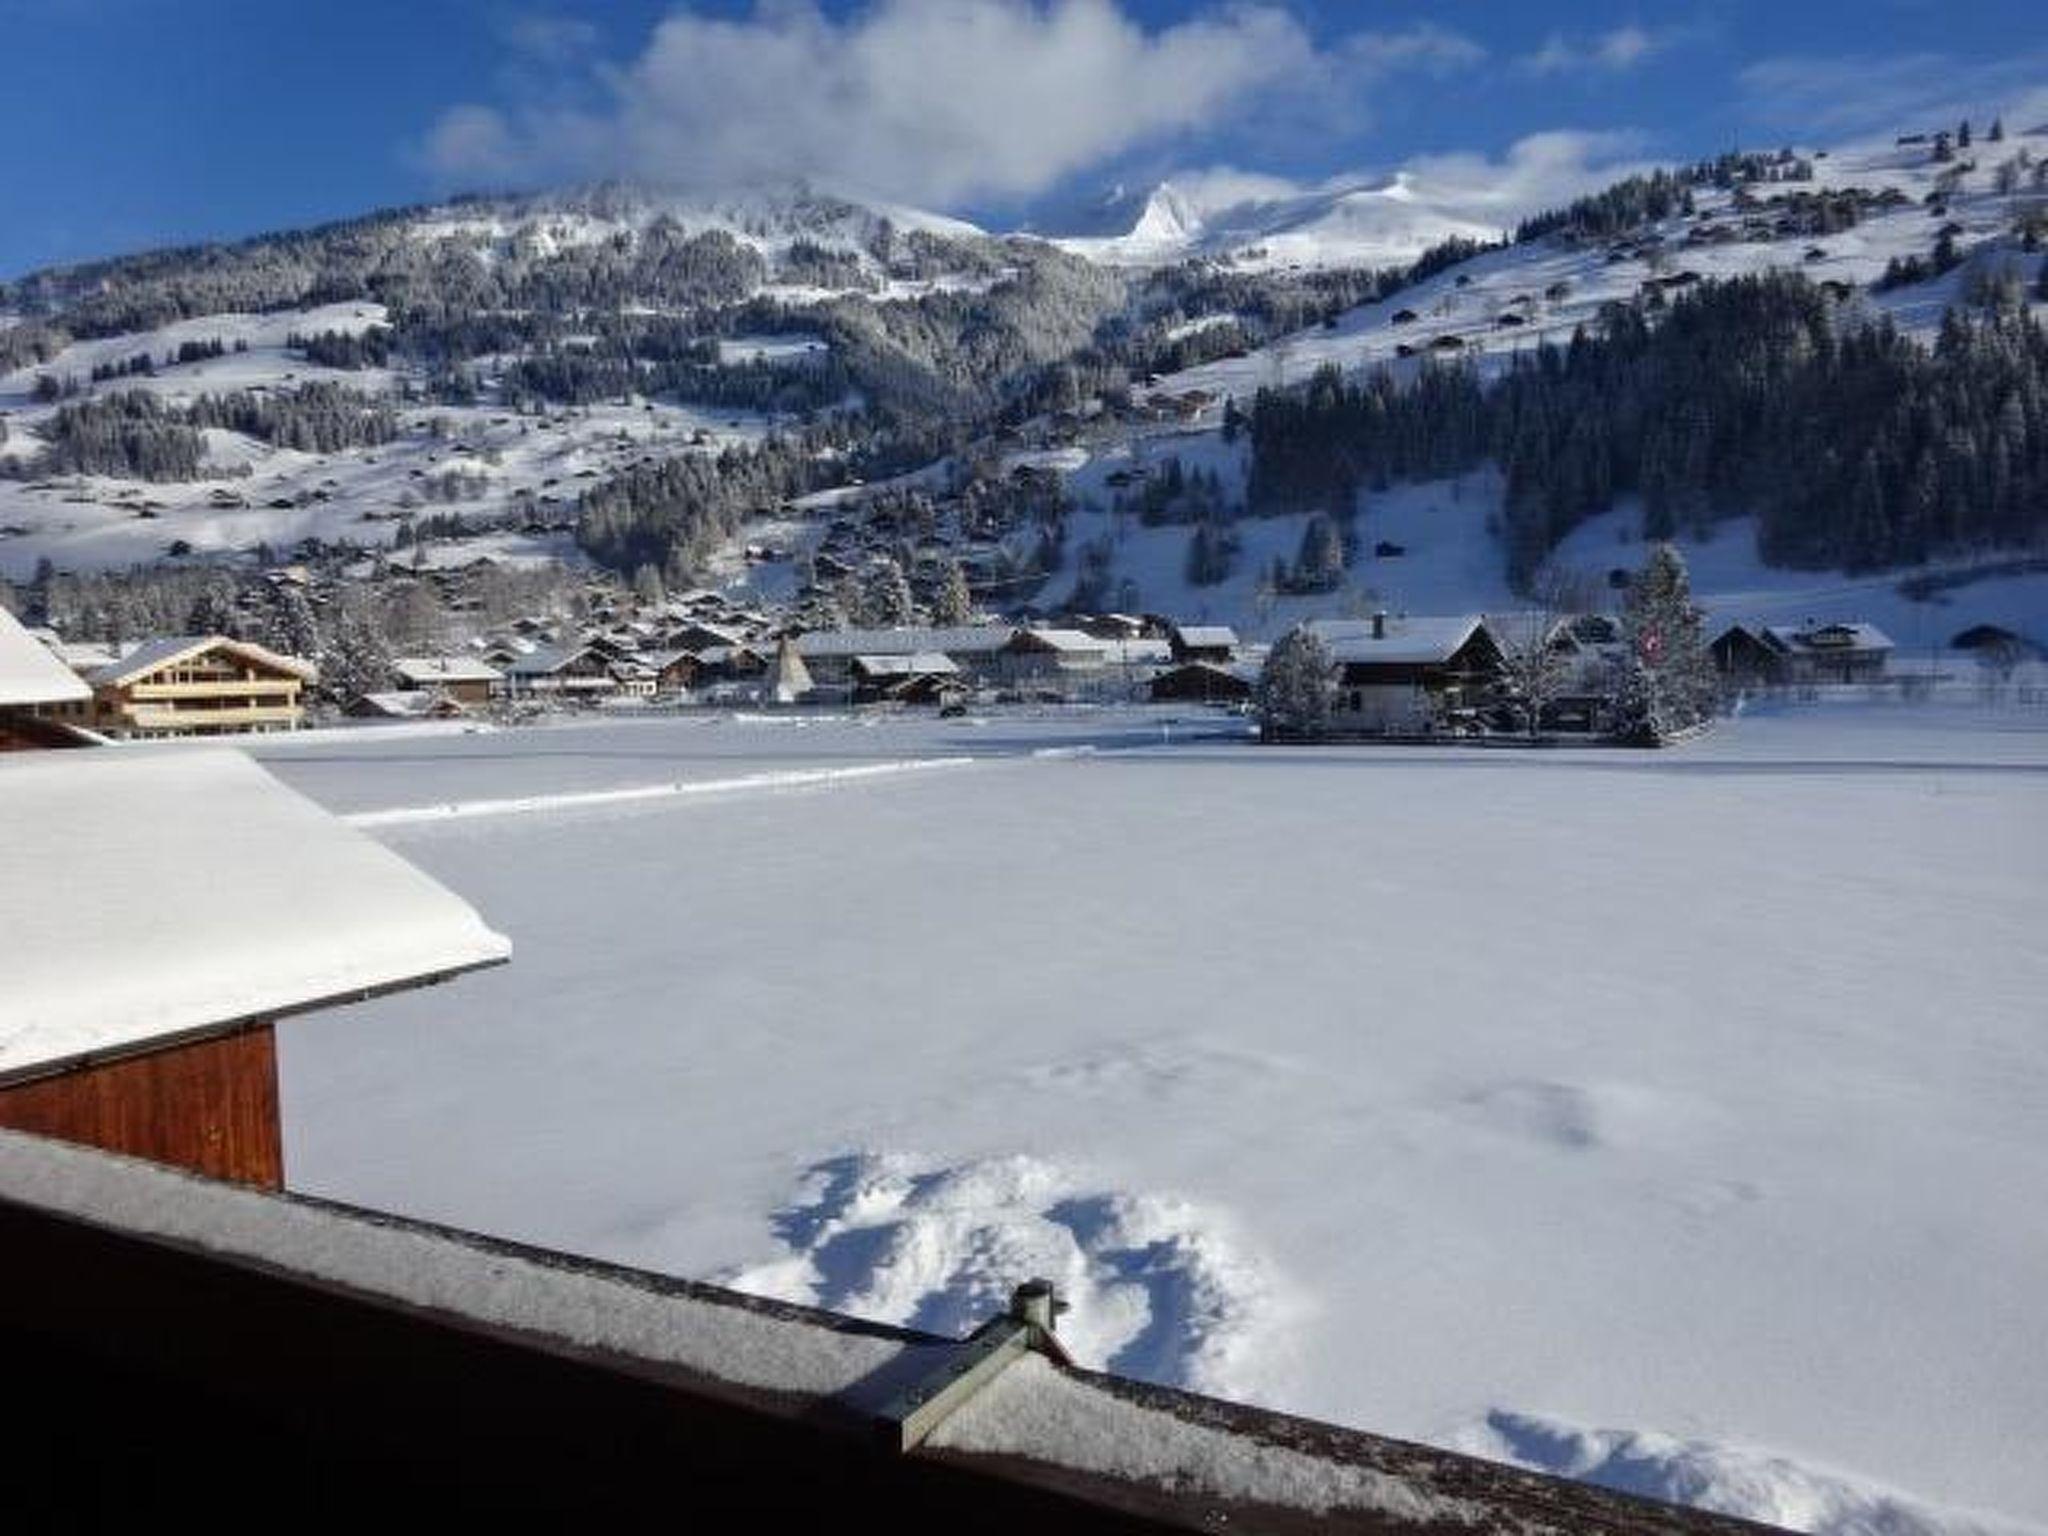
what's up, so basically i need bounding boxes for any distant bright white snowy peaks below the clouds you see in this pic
[1055,172,1501,266]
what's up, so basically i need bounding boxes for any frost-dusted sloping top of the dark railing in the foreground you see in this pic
[0,1130,1767,1536]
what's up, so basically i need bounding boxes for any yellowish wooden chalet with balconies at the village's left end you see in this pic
[86,635,319,737]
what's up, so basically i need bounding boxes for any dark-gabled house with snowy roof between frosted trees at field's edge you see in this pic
[1309,612,1501,735]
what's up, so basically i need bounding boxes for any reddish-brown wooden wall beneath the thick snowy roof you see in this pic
[0,1024,285,1190]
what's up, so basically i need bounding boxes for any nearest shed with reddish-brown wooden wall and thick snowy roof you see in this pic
[0,750,510,1186]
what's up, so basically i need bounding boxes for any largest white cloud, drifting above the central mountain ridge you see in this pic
[422,0,1485,205]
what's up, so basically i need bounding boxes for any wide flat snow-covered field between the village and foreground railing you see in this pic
[260,702,2048,1536]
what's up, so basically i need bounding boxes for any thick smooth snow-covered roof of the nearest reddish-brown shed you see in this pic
[0,750,510,1081]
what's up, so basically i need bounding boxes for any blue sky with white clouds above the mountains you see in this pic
[0,0,2048,274]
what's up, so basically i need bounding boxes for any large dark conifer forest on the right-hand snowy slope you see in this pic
[1247,272,2048,578]
